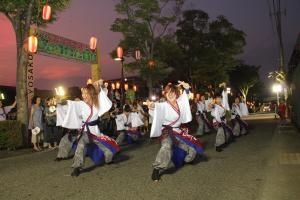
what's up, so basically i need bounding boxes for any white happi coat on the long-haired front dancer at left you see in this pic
[57,90,112,136]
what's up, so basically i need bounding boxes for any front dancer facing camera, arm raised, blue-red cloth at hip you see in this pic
[149,81,204,181]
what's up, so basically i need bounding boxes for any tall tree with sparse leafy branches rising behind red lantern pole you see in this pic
[111,0,184,95]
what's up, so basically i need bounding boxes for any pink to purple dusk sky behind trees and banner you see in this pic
[0,0,300,89]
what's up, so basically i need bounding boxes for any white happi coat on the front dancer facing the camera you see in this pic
[149,91,192,137]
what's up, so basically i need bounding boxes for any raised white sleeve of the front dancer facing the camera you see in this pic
[177,91,192,123]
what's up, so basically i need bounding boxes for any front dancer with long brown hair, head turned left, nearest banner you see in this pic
[58,80,120,176]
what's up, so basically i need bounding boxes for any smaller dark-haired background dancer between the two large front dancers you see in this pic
[116,105,144,144]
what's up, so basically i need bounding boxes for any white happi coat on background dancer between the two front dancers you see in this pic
[116,112,144,131]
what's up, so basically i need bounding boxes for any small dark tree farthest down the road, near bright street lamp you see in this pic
[229,63,260,100]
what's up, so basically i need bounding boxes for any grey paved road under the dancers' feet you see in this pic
[0,120,276,200]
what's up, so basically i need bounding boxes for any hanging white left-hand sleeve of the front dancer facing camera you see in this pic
[149,103,165,137]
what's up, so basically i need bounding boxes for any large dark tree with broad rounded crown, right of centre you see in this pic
[176,10,246,90]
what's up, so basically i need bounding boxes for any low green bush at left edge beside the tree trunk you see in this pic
[0,120,22,149]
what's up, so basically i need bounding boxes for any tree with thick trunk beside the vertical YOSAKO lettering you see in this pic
[0,0,70,142]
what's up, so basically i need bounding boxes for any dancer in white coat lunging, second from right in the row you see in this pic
[211,95,233,152]
